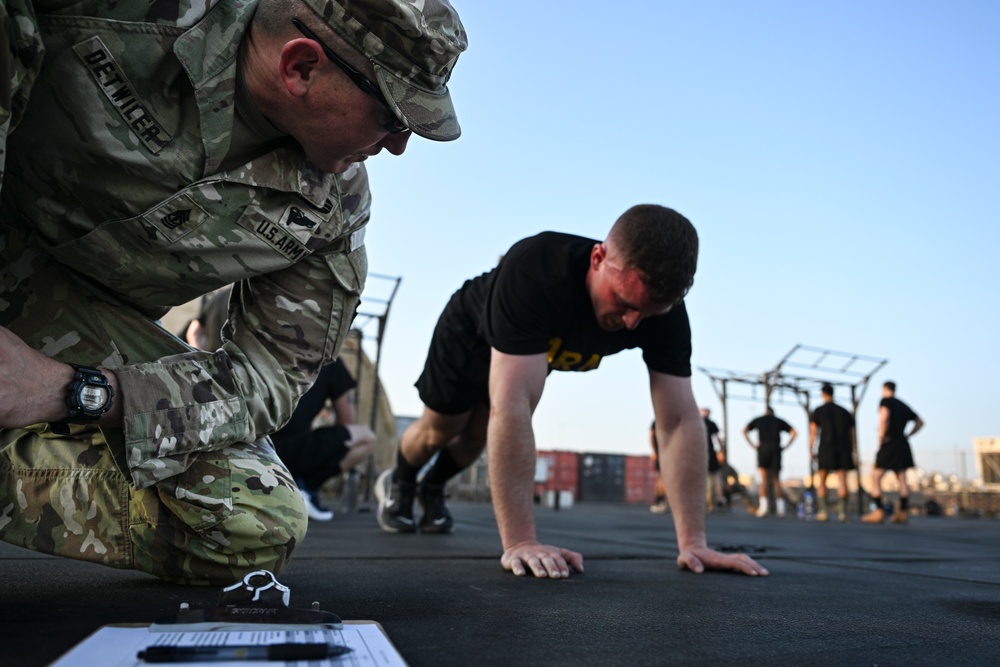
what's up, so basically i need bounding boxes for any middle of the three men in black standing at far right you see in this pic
[809,384,857,521]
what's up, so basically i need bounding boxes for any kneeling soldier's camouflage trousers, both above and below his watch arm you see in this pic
[0,229,307,584]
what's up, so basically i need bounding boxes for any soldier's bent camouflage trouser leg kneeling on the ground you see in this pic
[0,426,308,585]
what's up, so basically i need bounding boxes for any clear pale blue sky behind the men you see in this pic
[358,0,1000,476]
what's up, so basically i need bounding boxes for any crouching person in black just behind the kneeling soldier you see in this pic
[271,357,375,521]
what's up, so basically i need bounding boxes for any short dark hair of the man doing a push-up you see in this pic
[608,204,698,304]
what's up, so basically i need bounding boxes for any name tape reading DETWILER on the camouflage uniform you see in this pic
[73,37,172,155]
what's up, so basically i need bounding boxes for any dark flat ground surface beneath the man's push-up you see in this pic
[0,503,1000,667]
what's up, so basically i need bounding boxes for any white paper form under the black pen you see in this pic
[51,621,406,667]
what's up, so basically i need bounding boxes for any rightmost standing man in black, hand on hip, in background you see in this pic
[861,381,924,523]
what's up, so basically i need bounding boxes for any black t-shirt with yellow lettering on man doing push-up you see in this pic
[452,232,691,377]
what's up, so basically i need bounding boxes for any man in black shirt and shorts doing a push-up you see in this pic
[375,205,767,579]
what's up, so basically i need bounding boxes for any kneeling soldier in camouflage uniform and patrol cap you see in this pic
[0,0,466,584]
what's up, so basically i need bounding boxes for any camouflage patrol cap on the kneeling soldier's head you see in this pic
[305,0,468,141]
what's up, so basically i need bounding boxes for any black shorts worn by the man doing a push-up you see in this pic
[414,294,490,415]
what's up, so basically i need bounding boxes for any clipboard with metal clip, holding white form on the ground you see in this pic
[51,570,406,667]
